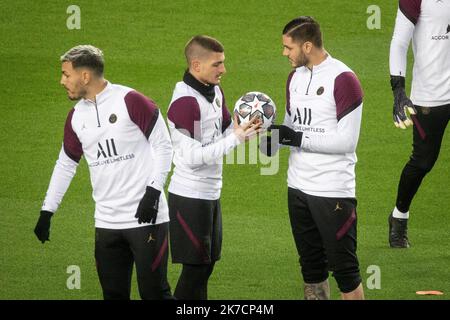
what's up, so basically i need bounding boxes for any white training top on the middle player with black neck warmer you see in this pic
[167,81,240,200]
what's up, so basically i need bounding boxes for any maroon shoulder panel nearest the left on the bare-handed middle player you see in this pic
[167,96,201,141]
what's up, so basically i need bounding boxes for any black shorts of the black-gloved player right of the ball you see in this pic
[288,188,359,283]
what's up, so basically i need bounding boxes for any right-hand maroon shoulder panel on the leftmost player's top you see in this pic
[125,91,159,139]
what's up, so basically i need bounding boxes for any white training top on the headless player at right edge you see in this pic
[389,0,450,107]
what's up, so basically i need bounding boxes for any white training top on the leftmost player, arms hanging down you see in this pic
[42,82,172,229]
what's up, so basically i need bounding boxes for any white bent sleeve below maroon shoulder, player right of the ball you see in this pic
[301,103,362,154]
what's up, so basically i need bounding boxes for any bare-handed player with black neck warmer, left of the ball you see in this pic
[167,35,261,300]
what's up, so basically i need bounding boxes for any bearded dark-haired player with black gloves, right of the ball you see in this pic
[260,16,364,300]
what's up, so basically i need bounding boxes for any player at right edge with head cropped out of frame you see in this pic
[389,0,450,248]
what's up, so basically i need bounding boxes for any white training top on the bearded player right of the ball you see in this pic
[284,56,363,198]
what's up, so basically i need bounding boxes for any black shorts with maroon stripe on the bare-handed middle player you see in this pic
[168,193,222,264]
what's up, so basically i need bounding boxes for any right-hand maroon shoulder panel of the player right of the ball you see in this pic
[334,71,363,121]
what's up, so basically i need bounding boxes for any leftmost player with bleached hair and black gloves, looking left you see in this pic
[34,45,172,299]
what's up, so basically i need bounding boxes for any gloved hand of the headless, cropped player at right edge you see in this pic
[391,76,417,129]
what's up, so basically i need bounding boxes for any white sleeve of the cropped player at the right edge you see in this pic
[389,9,414,77]
